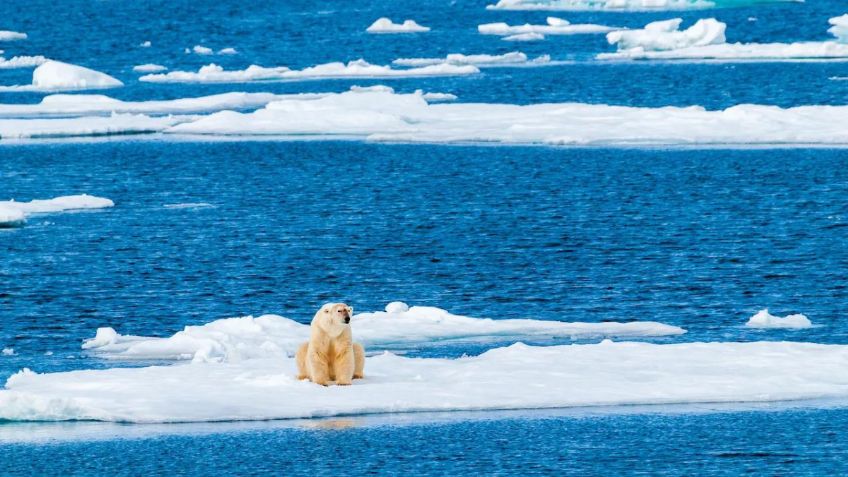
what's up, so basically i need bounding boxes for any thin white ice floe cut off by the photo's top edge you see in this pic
[486,0,802,11]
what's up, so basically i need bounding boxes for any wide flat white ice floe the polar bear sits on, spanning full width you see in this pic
[0,341,848,422]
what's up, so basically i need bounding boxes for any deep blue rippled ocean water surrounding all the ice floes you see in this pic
[0,0,848,475]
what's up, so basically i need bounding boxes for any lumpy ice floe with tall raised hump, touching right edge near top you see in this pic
[596,15,848,61]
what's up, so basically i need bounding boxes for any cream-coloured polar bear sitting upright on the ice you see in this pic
[295,303,365,386]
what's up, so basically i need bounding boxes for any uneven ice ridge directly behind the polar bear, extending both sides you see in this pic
[83,302,685,362]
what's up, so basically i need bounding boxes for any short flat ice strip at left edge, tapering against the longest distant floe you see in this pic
[0,113,183,140]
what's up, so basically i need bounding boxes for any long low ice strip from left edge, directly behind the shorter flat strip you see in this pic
[0,93,304,118]
